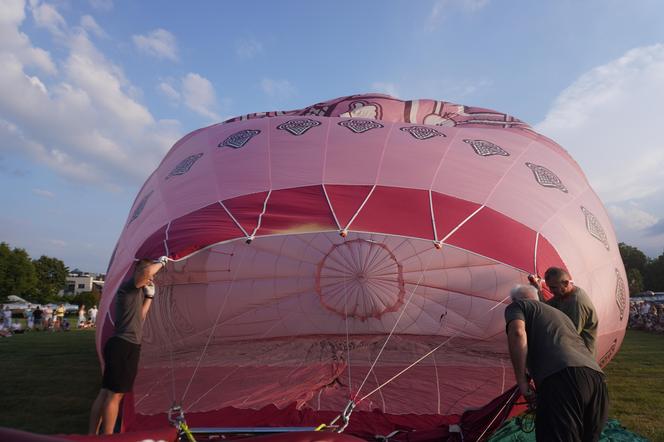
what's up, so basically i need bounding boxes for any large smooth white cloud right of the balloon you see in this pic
[535,44,664,254]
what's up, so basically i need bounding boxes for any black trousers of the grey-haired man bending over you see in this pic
[535,367,609,442]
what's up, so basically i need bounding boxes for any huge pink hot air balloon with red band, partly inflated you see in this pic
[97,94,628,440]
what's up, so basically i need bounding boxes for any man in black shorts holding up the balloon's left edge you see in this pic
[89,256,168,434]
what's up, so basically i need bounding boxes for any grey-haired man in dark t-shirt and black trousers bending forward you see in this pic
[505,285,608,441]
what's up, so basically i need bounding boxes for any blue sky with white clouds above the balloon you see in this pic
[0,0,664,272]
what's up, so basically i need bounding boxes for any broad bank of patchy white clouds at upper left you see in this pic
[0,0,180,189]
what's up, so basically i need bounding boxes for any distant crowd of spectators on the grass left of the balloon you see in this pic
[0,304,98,337]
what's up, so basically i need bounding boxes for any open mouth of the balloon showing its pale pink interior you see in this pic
[141,230,527,414]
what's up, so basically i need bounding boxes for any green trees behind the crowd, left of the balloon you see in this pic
[0,242,98,306]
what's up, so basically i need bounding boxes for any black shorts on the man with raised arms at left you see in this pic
[101,336,141,393]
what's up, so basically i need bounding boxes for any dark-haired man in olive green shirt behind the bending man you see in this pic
[528,267,597,356]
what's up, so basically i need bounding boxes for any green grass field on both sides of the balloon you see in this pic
[0,330,664,442]
